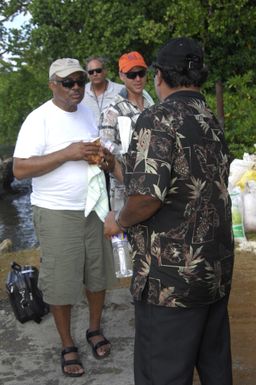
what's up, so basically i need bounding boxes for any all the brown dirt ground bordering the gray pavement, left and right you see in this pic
[0,244,256,385]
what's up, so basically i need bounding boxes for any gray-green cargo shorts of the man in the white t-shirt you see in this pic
[33,206,115,305]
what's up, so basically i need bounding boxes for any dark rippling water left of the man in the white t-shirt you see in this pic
[0,180,38,251]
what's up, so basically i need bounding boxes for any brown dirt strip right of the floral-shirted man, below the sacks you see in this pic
[229,246,256,385]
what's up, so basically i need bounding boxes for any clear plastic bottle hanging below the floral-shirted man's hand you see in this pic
[111,232,132,278]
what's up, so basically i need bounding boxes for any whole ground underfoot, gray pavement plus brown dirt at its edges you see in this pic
[0,251,256,385]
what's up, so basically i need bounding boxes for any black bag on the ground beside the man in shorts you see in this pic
[6,262,49,323]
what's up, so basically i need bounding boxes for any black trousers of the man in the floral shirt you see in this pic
[134,296,233,385]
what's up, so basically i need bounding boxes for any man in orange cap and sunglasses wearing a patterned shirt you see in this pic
[99,51,154,210]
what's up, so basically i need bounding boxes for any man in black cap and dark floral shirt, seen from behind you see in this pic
[105,38,234,385]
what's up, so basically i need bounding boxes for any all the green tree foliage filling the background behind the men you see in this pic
[0,0,256,157]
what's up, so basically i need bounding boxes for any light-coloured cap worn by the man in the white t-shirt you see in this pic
[49,58,86,78]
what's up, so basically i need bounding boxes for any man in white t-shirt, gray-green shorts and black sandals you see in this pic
[13,58,114,377]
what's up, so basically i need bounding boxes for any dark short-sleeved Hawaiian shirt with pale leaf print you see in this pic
[125,91,234,307]
